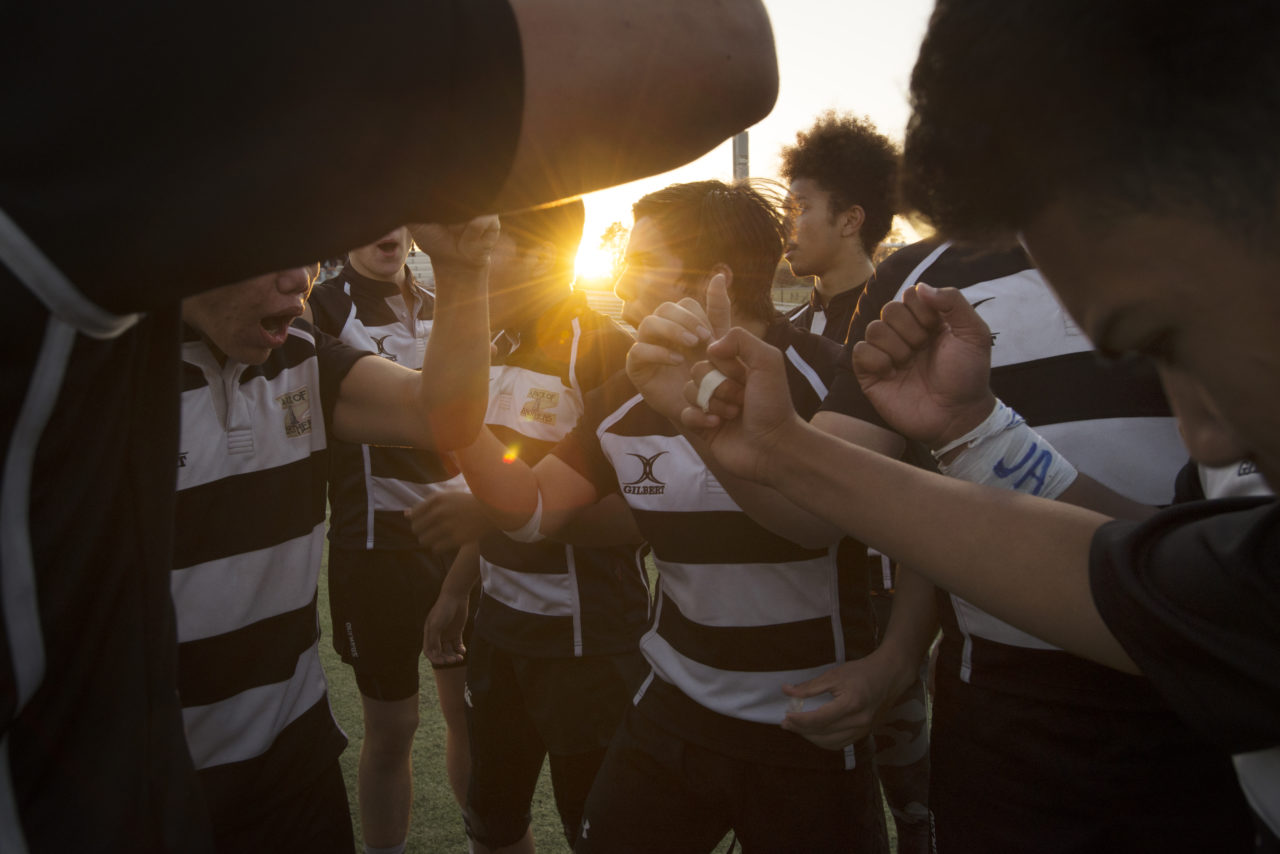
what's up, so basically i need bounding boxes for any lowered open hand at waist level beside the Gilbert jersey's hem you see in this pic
[782,653,910,750]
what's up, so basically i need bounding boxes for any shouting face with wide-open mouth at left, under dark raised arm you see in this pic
[182,265,316,365]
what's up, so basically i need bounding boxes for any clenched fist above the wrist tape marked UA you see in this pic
[852,284,995,448]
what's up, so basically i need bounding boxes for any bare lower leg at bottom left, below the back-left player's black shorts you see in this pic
[357,694,417,848]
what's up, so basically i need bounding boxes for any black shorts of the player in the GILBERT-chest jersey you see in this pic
[573,707,888,854]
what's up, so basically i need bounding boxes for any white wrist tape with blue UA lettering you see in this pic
[933,401,1078,498]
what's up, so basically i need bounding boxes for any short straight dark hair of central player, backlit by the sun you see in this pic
[631,181,787,320]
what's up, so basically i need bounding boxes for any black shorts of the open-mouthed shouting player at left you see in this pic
[214,759,356,854]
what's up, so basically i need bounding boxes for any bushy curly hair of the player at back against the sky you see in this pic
[782,110,901,256]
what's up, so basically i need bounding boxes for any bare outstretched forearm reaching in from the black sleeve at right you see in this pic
[760,420,1133,671]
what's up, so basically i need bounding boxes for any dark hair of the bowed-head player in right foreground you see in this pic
[904,0,1280,245]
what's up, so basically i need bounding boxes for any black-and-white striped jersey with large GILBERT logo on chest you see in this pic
[554,318,872,768]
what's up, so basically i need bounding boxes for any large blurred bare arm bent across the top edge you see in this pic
[495,0,778,210]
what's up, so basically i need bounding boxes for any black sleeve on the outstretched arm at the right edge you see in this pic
[1089,498,1280,753]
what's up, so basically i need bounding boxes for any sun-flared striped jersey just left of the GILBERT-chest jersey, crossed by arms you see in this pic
[475,293,650,658]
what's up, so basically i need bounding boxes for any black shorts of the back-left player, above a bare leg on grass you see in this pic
[329,548,479,702]
